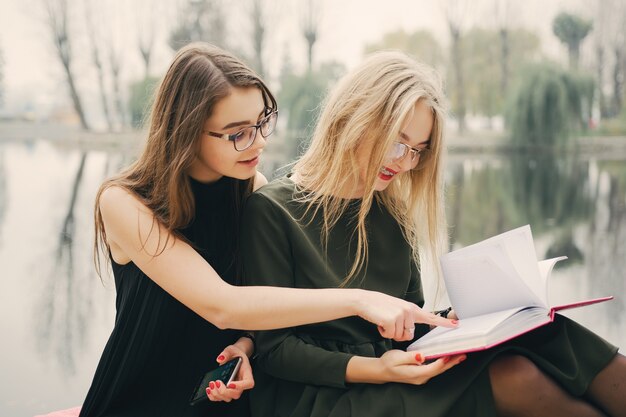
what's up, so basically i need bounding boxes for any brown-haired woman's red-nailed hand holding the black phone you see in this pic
[206,337,254,402]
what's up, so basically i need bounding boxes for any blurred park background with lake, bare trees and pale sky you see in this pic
[0,0,626,417]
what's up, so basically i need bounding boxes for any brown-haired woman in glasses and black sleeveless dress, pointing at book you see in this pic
[80,43,452,417]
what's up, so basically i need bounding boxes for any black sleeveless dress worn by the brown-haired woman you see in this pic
[80,177,249,417]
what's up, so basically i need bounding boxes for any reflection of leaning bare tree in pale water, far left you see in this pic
[37,152,97,374]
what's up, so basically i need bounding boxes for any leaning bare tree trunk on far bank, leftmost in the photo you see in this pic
[42,0,90,130]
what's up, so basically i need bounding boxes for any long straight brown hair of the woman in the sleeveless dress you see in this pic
[94,43,277,276]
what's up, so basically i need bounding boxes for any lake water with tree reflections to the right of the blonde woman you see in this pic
[447,153,626,346]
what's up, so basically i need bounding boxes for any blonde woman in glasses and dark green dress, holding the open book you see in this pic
[242,52,626,417]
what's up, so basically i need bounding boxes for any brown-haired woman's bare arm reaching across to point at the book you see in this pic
[99,187,451,334]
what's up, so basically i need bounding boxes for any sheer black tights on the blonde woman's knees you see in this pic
[489,354,626,417]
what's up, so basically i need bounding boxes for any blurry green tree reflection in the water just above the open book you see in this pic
[448,152,592,256]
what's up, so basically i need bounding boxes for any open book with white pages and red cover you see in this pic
[407,225,613,359]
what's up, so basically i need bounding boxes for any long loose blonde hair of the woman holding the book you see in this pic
[294,51,446,286]
